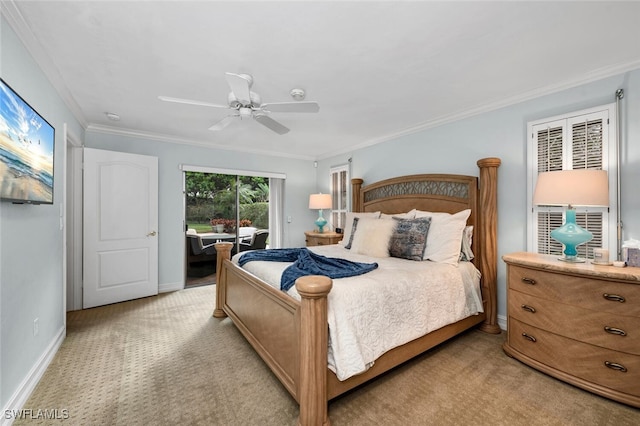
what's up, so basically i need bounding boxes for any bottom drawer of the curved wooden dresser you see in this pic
[508,317,640,396]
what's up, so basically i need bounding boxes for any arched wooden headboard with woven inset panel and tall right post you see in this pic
[351,157,500,333]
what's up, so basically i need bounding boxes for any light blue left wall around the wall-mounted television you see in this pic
[0,18,84,407]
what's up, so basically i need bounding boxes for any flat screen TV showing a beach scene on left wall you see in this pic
[0,79,55,204]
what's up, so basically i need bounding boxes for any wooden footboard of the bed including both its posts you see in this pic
[213,243,335,425]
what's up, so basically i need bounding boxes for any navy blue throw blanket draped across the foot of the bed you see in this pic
[238,248,378,291]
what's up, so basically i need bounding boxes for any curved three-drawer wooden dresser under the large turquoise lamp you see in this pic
[503,252,640,407]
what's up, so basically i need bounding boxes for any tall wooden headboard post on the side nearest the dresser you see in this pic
[478,157,501,334]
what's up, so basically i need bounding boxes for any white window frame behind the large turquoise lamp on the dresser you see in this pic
[527,103,618,258]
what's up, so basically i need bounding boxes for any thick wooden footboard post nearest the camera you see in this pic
[296,275,333,426]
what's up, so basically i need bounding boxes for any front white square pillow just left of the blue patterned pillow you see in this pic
[351,217,397,257]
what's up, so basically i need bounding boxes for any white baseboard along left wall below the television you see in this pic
[0,326,67,426]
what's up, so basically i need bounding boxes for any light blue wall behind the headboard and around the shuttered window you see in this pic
[318,70,640,317]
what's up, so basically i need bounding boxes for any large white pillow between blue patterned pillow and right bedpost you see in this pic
[415,209,471,265]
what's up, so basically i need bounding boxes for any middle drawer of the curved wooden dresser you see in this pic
[509,290,640,355]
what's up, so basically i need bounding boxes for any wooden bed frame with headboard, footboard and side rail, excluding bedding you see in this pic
[213,158,500,425]
